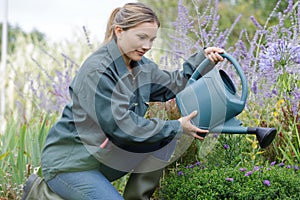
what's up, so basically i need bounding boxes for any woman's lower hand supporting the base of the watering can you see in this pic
[178,111,208,140]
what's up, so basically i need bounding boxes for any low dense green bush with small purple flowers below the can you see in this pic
[159,162,300,200]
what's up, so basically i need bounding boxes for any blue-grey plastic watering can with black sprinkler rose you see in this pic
[176,53,277,148]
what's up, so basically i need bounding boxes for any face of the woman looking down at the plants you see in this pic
[115,22,158,67]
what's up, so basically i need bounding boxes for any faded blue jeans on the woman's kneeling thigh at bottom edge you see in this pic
[47,170,124,200]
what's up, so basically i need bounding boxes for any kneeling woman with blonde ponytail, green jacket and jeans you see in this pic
[42,3,223,200]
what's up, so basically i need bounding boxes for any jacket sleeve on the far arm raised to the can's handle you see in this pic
[150,50,214,102]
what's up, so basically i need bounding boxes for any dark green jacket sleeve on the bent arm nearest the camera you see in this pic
[77,67,182,153]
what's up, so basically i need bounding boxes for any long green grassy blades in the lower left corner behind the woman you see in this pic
[0,113,55,199]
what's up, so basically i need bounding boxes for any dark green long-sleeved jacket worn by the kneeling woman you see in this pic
[42,41,211,181]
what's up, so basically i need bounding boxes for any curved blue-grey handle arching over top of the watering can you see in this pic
[189,53,248,102]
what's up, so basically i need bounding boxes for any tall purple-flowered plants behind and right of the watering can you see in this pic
[165,0,300,164]
